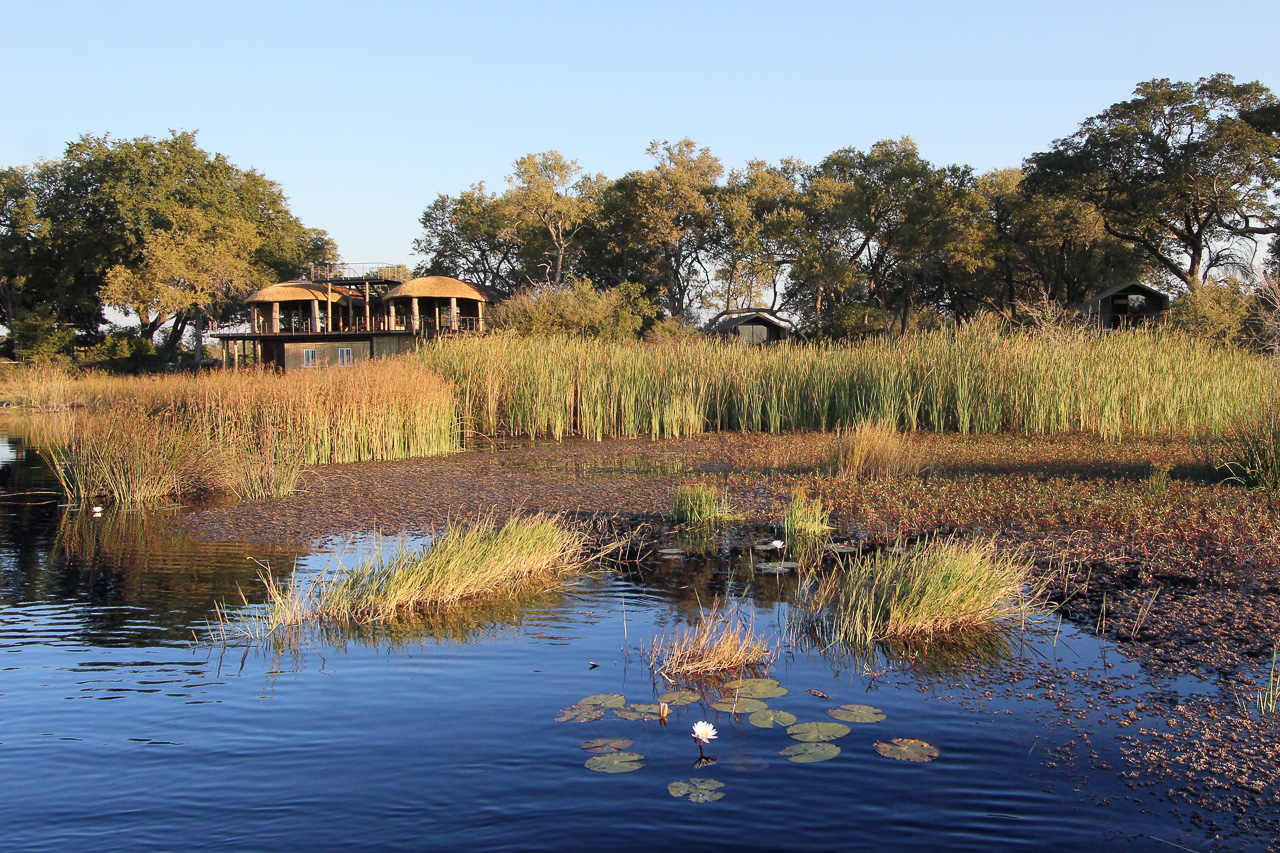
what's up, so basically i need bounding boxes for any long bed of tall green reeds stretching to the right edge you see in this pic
[419,323,1277,441]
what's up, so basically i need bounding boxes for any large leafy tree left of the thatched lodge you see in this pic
[0,132,335,336]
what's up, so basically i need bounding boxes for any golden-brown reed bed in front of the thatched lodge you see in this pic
[8,360,460,505]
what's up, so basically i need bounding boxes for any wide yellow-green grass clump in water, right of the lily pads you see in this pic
[804,539,1030,646]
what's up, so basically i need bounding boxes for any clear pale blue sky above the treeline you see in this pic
[0,0,1280,264]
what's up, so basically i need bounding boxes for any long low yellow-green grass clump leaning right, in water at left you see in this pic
[241,515,586,627]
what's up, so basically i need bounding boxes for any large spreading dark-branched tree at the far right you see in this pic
[1027,74,1280,286]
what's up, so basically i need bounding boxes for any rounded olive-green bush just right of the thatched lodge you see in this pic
[492,279,658,341]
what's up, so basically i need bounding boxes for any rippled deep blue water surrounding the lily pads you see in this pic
[0,427,1249,850]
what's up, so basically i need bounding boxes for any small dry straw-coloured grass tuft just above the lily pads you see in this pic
[649,601,776,681]
